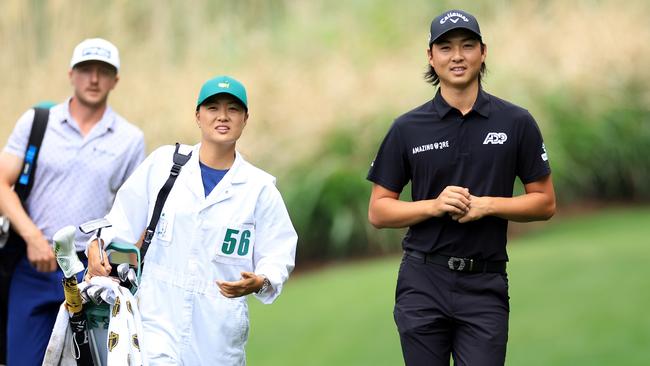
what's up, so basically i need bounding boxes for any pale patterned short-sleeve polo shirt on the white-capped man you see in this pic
[4,99,144,250]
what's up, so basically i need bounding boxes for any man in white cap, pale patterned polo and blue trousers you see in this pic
[0,38,144,365]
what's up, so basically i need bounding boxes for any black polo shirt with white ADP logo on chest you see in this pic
[367,89,551,261]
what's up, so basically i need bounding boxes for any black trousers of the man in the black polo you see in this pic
[394,255,510,366]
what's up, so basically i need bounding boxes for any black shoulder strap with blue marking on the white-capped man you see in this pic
[14,108,50,203]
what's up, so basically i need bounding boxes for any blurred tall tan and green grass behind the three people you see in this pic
[0,0,650,260]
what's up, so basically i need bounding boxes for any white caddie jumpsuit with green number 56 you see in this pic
[94,145,297,365]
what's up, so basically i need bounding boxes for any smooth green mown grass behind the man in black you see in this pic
[247,208,650,366]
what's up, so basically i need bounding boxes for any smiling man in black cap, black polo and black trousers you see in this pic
[368,10,555,366]
